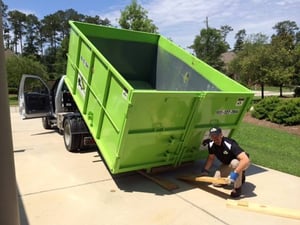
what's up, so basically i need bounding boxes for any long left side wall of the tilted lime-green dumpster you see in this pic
[65,25,130,172]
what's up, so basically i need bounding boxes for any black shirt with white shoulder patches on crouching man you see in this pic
[208,137,244,165]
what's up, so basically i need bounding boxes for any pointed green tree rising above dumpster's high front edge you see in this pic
[119,0,158,33]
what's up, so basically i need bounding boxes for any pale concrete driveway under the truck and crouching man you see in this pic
[11,108,300,225]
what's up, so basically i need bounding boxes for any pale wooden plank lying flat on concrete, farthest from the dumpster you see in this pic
[226,199,300,220]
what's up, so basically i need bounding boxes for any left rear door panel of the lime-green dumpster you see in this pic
[119,91,198,171]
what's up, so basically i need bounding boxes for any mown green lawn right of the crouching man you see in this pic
[233,123,300,177]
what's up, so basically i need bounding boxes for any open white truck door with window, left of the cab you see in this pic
[18,74,53,119]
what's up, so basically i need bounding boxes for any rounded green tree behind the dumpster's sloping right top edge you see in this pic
[189,27,229,71]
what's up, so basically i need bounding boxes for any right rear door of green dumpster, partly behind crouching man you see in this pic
[176,92,252,165]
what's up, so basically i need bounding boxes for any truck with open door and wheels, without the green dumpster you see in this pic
[19,74,94,151]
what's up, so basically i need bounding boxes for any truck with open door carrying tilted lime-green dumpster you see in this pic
[19,21,254,174]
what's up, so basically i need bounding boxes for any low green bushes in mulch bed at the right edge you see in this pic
[251,97,300,126]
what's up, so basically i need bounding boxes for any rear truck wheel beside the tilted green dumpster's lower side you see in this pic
[64,119,81,152]
